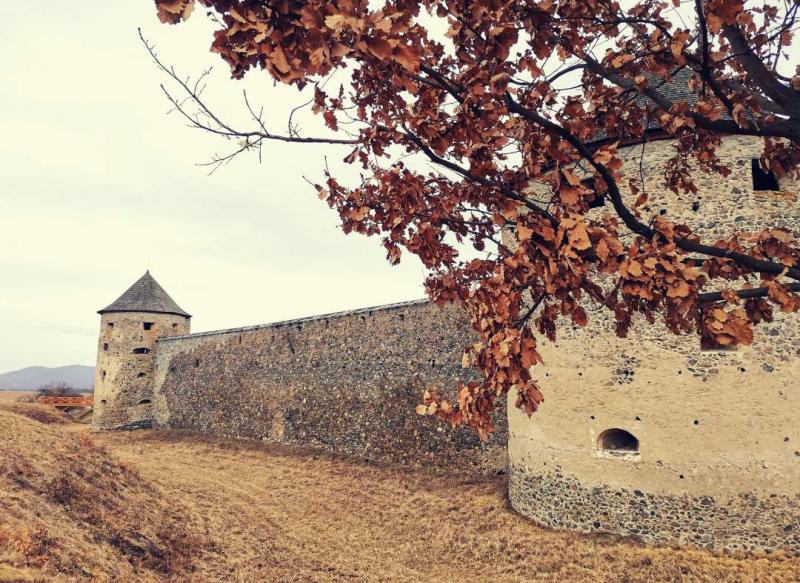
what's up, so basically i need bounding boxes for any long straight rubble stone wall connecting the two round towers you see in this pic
[152,300,507,473]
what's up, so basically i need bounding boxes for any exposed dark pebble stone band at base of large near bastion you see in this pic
[509,465,800,555]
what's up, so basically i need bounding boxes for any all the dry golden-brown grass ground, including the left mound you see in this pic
[0,404,800,582]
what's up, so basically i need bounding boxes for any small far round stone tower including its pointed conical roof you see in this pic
[92,271,191,429]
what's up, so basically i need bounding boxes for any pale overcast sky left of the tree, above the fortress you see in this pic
[0,0,432,372]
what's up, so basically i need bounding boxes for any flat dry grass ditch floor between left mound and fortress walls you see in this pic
[98,432,800,582]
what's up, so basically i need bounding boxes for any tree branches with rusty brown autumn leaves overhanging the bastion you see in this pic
[150,0,800,437]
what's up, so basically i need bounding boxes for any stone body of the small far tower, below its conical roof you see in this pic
[92,312,189,429]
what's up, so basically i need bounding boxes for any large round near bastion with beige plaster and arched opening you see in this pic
[508,138,800,554]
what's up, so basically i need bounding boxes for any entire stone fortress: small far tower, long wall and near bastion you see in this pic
[94,137,800,553]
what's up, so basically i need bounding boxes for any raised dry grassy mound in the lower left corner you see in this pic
[0,404,209,582]
